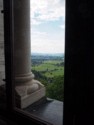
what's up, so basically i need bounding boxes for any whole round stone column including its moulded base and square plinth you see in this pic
[13,0,45,108]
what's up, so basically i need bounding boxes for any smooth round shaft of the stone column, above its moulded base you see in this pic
[14,0,31,76]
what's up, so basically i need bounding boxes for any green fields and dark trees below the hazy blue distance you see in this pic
[32,58,64,101]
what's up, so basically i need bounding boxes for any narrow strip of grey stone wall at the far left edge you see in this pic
[0,0,5,85]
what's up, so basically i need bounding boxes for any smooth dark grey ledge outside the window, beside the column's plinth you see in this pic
[24,98,63,125]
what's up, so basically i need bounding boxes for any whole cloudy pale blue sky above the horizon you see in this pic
[30,0,65,53]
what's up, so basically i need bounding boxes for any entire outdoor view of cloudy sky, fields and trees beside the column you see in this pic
[31,0,65,101]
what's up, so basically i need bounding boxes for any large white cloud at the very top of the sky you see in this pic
[31,0,65,25]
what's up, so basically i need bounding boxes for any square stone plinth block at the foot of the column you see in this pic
[15,80,46,109]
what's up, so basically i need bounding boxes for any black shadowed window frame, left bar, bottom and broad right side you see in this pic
[0,0,94,125]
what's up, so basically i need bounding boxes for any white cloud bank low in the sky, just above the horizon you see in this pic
[31,30,64,53]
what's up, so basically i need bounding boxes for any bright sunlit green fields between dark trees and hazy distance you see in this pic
[32,60,64,78]
